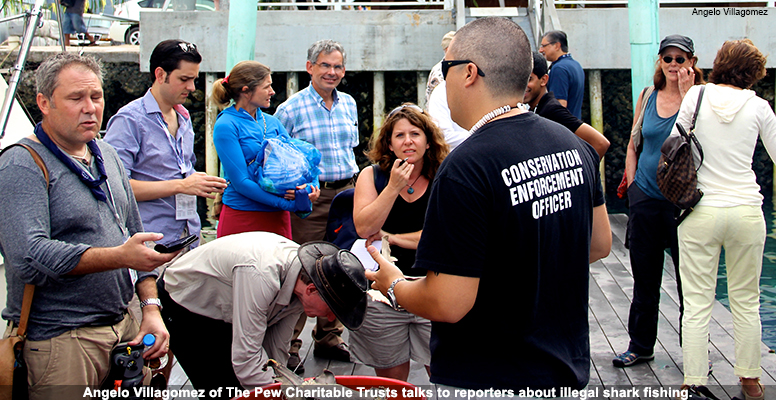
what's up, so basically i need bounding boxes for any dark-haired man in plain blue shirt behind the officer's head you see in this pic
[539,31,585,119]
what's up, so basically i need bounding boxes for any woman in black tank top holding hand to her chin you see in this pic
[350,103,449,381]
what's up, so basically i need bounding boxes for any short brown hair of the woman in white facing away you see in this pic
[709,39,768,89]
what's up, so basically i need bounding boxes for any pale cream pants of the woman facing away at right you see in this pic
[679,206,766,385]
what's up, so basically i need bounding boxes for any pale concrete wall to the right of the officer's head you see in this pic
[558,7,776,69]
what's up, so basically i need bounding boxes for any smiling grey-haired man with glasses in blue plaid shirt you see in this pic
[275,39,358,371]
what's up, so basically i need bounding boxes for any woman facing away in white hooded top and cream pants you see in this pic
[671,39,776,400]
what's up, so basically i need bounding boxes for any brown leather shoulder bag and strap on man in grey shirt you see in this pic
[0,143,49,400]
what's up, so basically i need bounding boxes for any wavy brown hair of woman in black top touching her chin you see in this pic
[365,103,450,181]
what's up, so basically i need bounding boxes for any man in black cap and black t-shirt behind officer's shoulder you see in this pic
[523,51,609,158]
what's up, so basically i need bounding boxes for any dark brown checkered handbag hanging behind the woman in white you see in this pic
[657,86,706,225]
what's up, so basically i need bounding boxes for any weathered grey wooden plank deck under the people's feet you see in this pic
[162,214,776,400]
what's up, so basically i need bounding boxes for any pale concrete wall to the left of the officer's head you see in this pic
[140,10,455,72]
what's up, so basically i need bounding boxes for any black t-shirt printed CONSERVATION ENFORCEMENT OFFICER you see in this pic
[415,113,604,395]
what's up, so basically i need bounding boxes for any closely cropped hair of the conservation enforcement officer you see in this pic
[447,17,533,97]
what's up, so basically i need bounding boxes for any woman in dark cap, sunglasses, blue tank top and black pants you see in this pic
[612,35,703,368]
